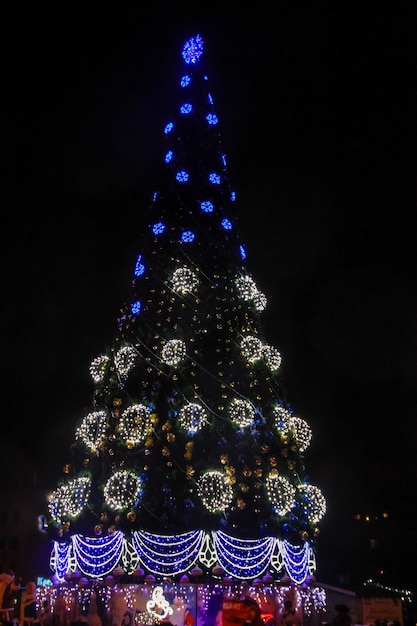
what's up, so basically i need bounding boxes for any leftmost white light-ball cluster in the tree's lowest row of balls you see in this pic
[48,476,91,523]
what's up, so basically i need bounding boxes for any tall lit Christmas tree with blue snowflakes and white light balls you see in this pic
[48,35,326,583]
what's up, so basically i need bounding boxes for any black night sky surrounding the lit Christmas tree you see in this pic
[0,1,417,584]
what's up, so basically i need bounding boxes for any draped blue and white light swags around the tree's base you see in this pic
[50,530,315,583]
